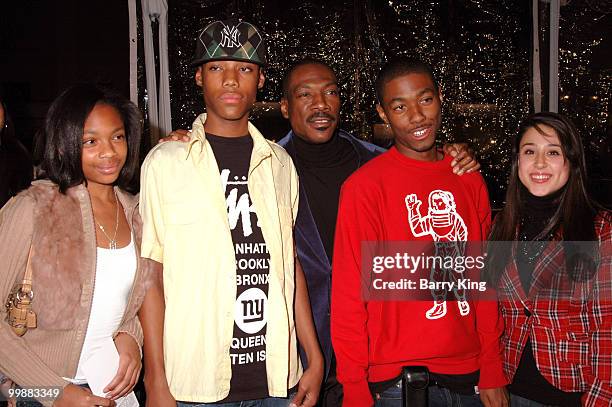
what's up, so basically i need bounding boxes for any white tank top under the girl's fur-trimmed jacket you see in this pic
[71,239,137,384]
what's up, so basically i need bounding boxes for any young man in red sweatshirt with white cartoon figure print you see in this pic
[331,59,508,407]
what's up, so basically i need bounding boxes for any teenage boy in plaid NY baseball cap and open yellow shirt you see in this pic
[140,21,323,406]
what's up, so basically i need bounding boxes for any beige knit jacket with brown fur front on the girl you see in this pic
[0,181,154,405]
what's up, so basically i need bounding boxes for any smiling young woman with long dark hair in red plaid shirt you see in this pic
[489,113,612,407]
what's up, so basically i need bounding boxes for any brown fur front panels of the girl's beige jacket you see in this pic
[25,181,144,330]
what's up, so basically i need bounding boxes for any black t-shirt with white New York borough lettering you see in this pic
[206,134,270,403]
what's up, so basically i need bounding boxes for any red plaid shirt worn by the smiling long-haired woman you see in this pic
[498,211,612,407]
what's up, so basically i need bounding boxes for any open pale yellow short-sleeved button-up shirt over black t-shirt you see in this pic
[140,114,302,403]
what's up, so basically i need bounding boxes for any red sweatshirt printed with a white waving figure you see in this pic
[331,148,507,407]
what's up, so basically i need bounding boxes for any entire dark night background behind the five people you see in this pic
[0,0,612,208]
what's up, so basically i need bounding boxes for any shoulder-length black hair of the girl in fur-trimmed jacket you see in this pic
[35,84,142,193]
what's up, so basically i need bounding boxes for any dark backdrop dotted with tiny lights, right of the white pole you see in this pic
[149,0,612,208]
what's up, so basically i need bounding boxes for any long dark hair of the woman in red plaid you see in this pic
[488,112,598,282]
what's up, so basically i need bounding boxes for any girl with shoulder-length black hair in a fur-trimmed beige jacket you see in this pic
[0,85,151,407]
